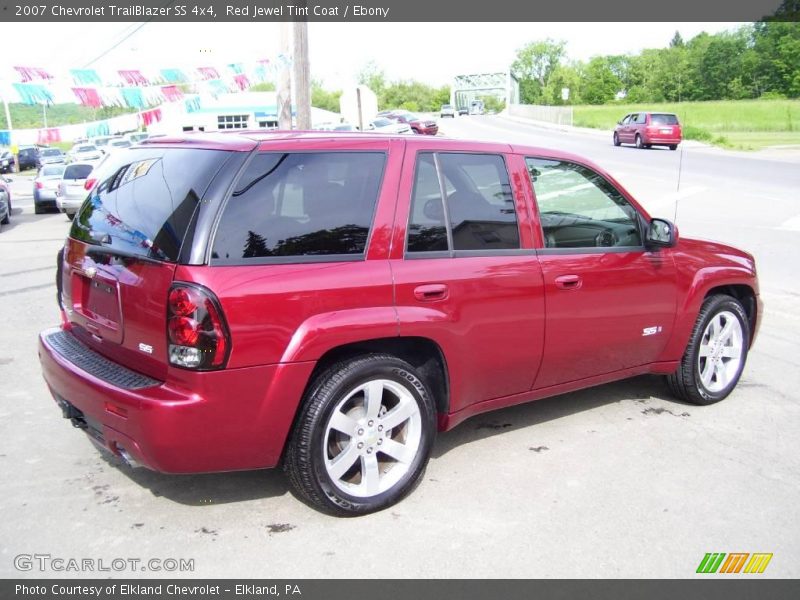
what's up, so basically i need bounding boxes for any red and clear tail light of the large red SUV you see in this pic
[167,283,231,371]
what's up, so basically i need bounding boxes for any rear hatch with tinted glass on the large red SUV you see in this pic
[61,146,230,379]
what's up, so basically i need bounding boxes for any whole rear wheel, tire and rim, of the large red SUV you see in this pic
[284,354,436,516]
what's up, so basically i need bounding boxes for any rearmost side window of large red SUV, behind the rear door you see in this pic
[212,152,385,261]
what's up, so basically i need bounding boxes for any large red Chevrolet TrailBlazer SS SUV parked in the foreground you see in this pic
[39,132,761,514]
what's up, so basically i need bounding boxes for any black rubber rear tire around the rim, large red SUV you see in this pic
[283,354,436,516]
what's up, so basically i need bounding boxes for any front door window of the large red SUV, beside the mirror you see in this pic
[526,158,642,248]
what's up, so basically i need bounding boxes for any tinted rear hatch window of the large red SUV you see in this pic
[70,147,229,262]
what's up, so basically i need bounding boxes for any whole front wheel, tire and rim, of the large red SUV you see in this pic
[667,294,750,405]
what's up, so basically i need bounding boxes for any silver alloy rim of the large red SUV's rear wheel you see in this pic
[322,379,422,498]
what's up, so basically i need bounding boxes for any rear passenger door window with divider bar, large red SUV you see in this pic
[407,152,520,252]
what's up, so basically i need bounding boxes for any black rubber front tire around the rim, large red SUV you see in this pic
[667,294,750,406]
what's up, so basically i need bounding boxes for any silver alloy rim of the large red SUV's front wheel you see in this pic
[697,310,744,393]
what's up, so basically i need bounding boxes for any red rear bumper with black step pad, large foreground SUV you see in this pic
[39,329,314,473]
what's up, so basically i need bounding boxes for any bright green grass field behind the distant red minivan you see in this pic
[573,100,800,150]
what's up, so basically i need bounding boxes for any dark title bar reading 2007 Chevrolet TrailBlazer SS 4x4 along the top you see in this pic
[0,0,800,22]
